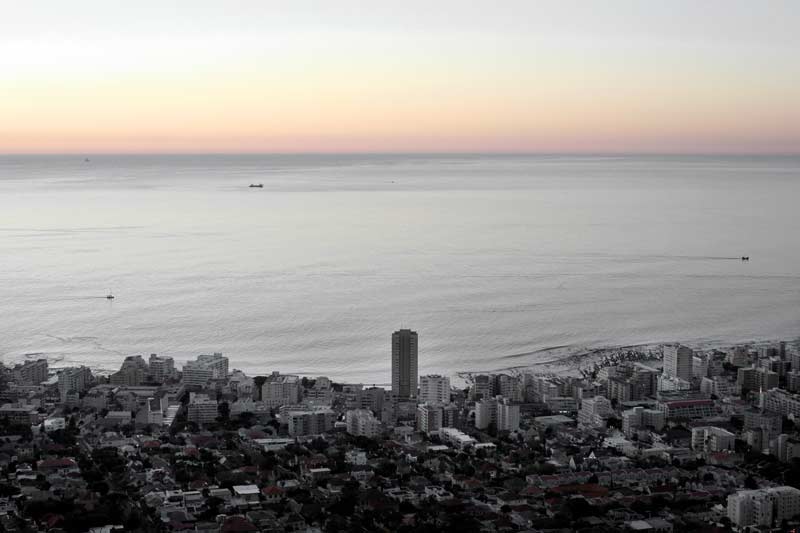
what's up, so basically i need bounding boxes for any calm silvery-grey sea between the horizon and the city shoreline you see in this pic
[0,155,800,383]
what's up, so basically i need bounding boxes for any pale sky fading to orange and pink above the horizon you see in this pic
[0,0,800,154]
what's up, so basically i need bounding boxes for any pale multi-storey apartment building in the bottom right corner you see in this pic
[728,486,800,528]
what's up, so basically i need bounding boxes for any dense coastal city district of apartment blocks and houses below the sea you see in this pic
[0,329,800,533]
